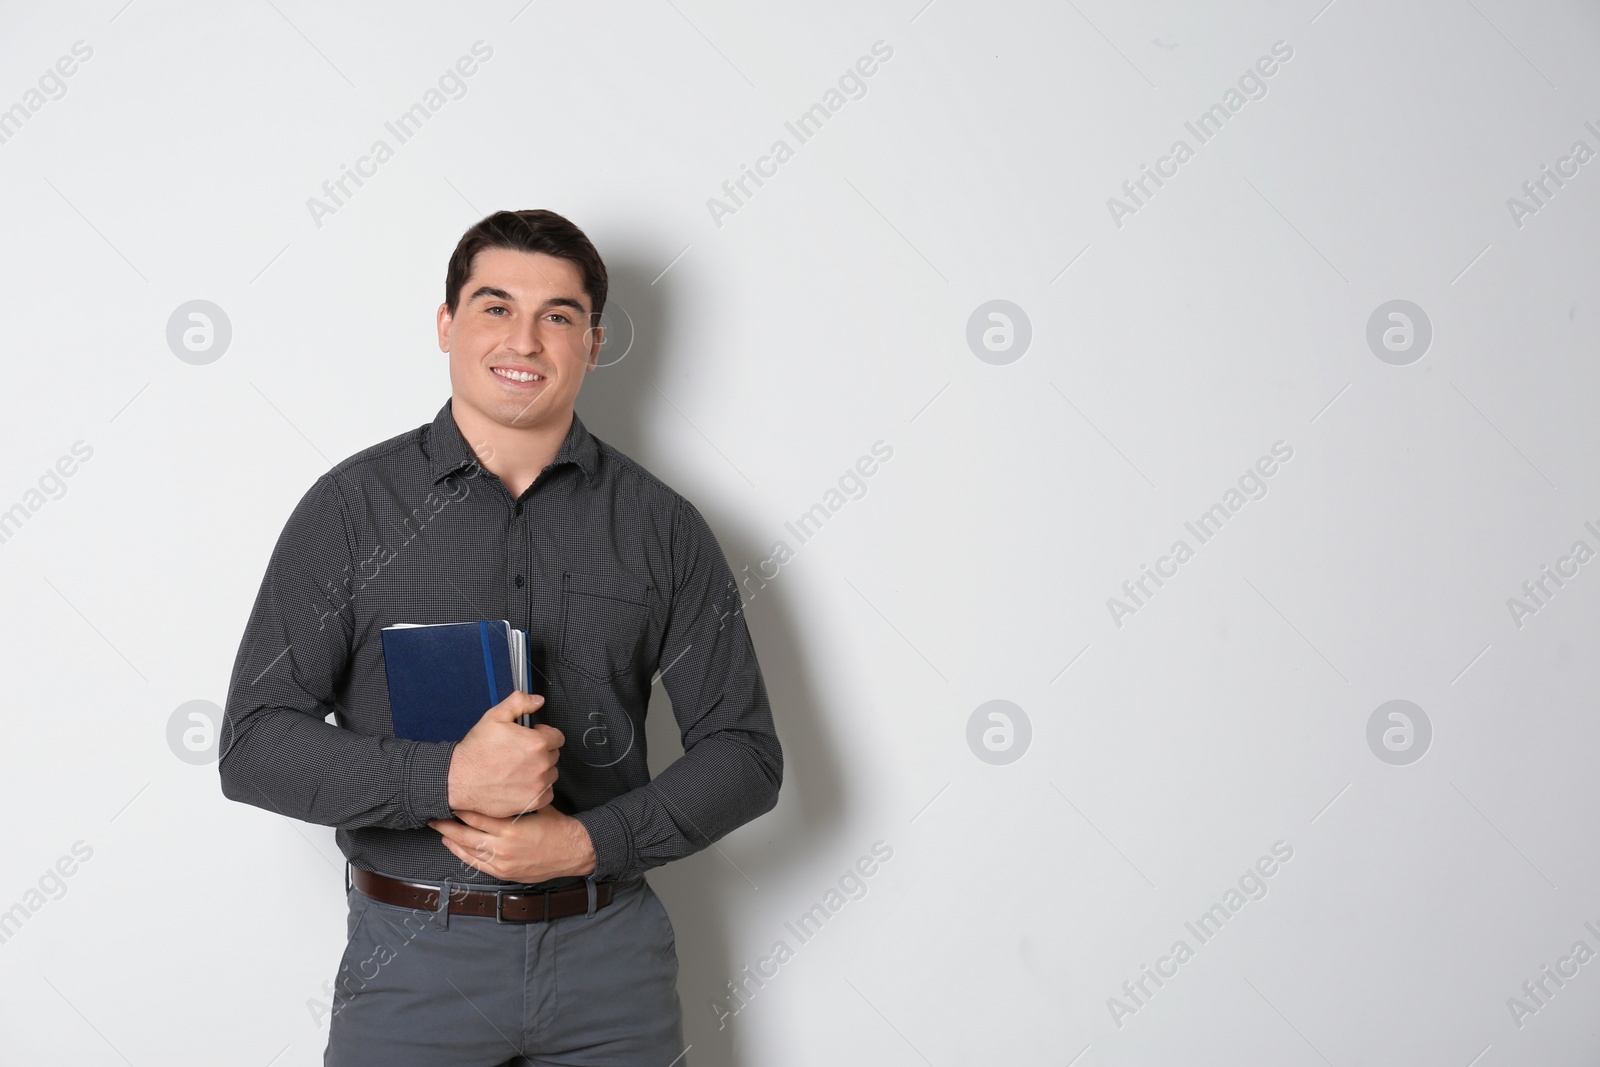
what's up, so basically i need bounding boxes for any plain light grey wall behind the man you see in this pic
[0,0,1600,1067]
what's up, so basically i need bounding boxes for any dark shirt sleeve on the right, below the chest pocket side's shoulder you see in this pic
[576,499,784,880]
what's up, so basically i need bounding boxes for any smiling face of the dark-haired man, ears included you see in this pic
[438,248,603,429]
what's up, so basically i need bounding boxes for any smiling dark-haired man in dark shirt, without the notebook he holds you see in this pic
[218,211,782,1067]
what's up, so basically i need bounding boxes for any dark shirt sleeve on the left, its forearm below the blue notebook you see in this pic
[218,472,454,829]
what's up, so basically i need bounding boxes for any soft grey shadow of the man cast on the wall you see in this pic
[578,251,848,1067]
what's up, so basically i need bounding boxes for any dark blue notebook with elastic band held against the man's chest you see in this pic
[382,619,533,741]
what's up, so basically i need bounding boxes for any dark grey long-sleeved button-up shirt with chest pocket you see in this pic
[218,402,782,885]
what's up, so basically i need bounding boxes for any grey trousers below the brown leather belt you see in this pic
[323,878,688,1067]
